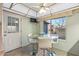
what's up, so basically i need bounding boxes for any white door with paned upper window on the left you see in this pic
[3,15,21,52]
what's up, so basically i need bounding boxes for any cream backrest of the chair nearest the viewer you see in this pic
[38,39,52,48]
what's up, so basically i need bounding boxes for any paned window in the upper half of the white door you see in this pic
[8,16,19,33]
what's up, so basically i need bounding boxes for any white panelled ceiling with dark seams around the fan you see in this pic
[3,3,79,17]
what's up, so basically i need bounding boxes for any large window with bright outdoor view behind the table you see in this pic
[47,17,66,39]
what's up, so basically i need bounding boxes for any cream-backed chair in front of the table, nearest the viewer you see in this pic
[38,39,52,56]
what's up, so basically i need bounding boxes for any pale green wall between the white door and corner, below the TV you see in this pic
[22,17,39,46]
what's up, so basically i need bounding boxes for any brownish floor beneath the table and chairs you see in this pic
[5,45,66,56]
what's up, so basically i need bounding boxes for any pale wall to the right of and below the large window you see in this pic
[54,13,79,51]
